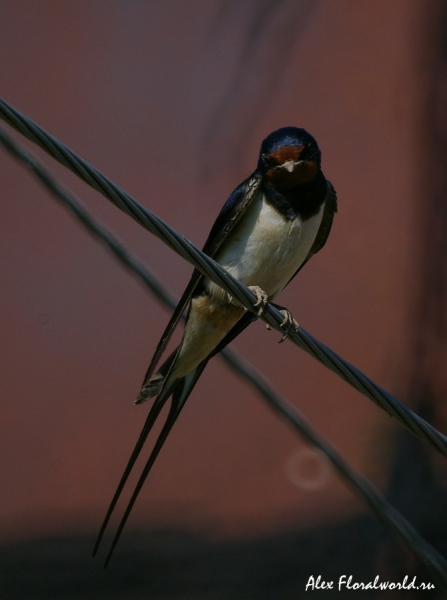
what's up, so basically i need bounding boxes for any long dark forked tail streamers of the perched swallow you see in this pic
[93,361,208,568]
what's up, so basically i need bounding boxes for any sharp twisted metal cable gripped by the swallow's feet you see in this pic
[0,98,447,457]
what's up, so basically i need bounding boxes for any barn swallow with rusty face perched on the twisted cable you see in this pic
[93,127,337,566]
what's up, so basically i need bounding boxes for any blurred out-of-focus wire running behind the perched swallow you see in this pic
[0,128,447,590]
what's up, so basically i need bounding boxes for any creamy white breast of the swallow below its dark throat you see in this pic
[207,192,323,300]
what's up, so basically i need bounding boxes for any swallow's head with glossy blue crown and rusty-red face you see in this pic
[258,127,321,189]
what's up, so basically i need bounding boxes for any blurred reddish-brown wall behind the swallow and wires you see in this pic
[0,0,421,538]
